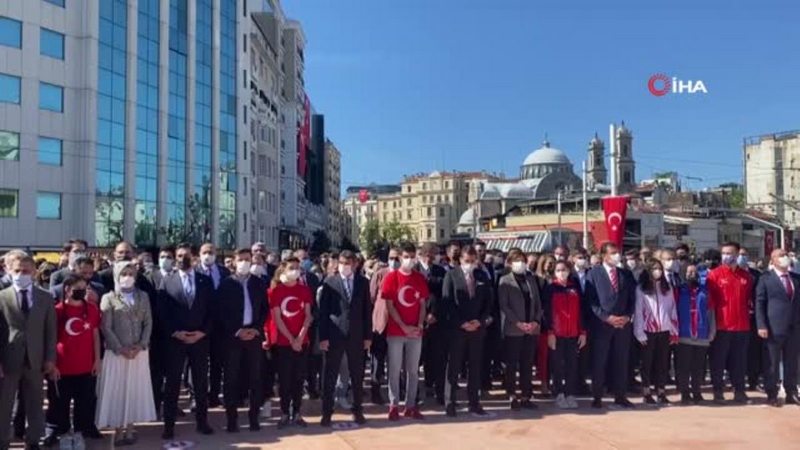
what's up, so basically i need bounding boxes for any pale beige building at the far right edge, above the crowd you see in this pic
[744,131,800,230]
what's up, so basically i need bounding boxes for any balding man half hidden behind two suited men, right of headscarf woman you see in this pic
[195,242,231,408]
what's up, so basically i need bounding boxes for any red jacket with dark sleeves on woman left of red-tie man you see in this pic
[544,279,586,338]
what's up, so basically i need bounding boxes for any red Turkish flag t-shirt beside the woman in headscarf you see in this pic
[56,302,100,375]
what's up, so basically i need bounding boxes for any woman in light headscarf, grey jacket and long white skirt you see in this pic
[96,261,156,446]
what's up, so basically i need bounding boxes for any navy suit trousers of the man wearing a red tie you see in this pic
[592,323,631,399]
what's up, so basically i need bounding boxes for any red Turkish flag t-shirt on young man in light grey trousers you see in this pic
[381,270,429,336]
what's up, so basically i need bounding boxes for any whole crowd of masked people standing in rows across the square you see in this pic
[0,239,800,449]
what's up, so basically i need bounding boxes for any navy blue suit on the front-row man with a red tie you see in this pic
[584,265,636,399]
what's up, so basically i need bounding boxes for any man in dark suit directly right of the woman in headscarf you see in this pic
[158,244,214,439]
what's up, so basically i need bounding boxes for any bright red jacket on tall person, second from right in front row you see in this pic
[707,265,753,331]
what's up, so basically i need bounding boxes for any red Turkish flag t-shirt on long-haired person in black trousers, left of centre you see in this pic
[264,283,311,347]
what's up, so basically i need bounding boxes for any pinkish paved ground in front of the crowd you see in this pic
[15,392,800,450]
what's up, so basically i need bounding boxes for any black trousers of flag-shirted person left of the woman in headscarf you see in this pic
[48,374,97,436]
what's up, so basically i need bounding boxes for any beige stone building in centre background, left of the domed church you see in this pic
[377,171,502,243]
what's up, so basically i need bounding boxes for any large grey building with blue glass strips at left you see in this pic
[0,0,250,248]
